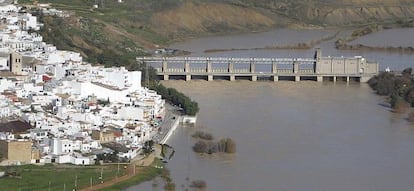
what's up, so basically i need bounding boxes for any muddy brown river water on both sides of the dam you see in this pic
[127,29,414,191]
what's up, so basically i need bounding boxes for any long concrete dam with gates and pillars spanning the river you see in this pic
[136,49,379,82]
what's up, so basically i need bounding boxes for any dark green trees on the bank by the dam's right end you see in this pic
[368,68,414,111]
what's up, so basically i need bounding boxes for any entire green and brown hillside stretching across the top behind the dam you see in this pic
[19,0,414,65]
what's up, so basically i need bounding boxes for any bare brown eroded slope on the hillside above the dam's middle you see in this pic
[150,2,280,35]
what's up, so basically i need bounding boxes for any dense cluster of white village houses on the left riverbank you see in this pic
[0,2,165,165]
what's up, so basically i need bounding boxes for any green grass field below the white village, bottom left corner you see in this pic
[0,165,125,191]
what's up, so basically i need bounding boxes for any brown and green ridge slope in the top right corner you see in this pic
[240,0,414,26]
